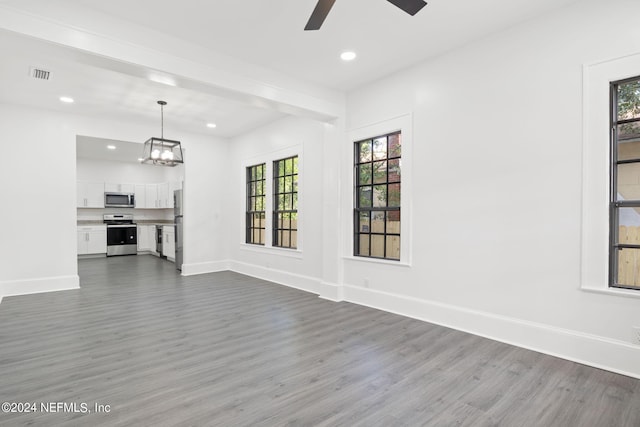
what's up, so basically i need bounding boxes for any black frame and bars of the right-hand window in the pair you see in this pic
[271,154,300,250]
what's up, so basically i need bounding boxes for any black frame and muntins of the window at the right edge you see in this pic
[609,76,640,290]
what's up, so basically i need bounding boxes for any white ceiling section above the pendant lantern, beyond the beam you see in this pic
[0,32,283,138]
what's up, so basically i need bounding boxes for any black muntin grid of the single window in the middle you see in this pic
[353,131,402,261]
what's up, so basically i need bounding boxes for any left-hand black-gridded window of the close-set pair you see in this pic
[245,163,266,245]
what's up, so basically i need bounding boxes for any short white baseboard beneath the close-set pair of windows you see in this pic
[229,261,341,301]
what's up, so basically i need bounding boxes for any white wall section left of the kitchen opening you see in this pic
[0,104,78,296]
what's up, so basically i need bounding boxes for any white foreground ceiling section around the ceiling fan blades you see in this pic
[72,0,576,90]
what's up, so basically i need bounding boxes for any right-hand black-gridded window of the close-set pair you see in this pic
[272,156,298,249]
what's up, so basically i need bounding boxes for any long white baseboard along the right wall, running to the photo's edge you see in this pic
[344,285,640,379]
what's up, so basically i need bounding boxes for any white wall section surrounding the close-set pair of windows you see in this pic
[226,117,332,293]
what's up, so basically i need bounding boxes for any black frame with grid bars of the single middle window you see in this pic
[353,130,402,262]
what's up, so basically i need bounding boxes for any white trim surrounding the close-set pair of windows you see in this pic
[240,145,304,254]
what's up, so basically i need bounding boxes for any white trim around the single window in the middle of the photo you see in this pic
[342,114,413,267]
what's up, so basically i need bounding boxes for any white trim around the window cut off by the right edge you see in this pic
[580,53,640,298]
